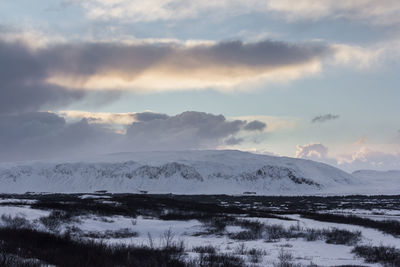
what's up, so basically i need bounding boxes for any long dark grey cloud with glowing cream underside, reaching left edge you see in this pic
[0,35,332,100]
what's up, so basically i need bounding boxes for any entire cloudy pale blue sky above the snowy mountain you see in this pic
[0,0,400,171]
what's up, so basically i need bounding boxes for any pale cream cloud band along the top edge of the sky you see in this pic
[81,0,400,25]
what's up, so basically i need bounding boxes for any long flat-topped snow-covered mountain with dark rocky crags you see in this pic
[0,150,360,195]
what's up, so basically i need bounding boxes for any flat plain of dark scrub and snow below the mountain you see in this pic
[0,192,400,267]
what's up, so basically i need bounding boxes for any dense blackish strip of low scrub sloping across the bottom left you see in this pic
[0,228,187,267]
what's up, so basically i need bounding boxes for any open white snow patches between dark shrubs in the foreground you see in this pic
[0,207,394,266]
